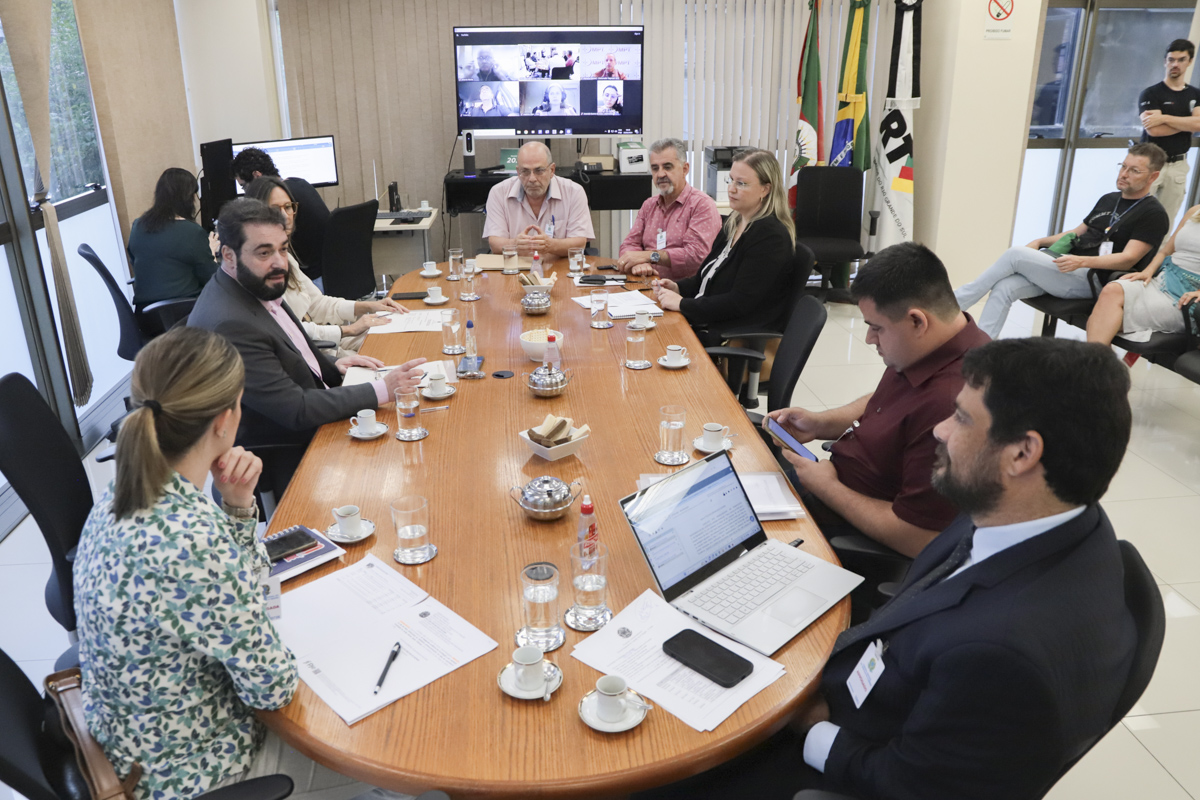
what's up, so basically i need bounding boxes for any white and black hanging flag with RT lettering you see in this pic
[874,0,923,251]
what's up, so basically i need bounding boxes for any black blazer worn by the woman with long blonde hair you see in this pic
[677,217,808,331]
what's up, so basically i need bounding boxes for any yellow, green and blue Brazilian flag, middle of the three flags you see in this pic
[829,0,871,172]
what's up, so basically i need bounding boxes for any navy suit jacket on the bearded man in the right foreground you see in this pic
[822,505,1136,800]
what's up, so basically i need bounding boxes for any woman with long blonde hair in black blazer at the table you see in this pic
[654,150,800,345]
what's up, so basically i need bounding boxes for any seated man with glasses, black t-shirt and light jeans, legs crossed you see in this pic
[954,143,1170,338]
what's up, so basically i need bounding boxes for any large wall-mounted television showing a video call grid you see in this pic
[454,25,644,139]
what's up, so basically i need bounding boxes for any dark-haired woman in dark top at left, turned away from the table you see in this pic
[128,167,217,311]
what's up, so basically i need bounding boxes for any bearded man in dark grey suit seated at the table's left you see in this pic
[187,198,425,500]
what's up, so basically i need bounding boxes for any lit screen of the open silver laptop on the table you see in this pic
[620,451,767,600]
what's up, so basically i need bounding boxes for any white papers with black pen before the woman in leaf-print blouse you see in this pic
[276,555,496,724]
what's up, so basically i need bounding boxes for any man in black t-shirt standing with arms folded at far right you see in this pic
[1138,38,1200,221]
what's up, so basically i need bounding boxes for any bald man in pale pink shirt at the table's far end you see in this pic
[484,142,595,257]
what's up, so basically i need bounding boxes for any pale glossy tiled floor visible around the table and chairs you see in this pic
[0,305,1200,800]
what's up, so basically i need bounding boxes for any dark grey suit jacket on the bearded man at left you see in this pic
[187,270,378,447]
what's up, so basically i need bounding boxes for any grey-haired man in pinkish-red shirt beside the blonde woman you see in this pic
[617,139,721,281]
